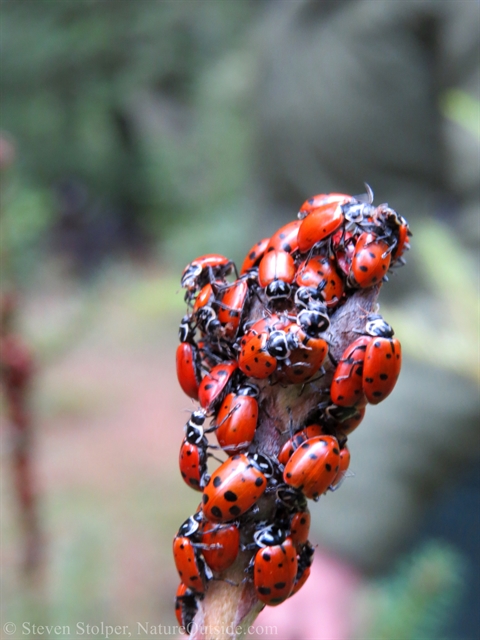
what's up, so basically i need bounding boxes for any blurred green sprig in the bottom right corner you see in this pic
[362,541,464,640]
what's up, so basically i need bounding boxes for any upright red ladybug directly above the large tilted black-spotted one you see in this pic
[215,385,258,455]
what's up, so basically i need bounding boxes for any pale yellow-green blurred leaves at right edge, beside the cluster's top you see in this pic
[382,220,480,381]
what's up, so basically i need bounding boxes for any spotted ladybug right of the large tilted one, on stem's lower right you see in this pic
[283,436,340,500]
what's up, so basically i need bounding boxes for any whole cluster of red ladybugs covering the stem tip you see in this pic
[174,187,410,628]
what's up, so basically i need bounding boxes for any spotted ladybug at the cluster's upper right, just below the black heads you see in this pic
[348,232,391,289]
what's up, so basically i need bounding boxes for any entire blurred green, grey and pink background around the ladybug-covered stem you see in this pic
[0,0,480,640]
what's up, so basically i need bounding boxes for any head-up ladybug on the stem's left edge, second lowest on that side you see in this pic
[173,516,213,594]
